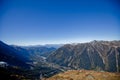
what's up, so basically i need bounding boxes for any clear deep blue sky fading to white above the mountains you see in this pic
[0,0,120,45]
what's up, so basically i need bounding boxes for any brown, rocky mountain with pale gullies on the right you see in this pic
[47,41,120,72]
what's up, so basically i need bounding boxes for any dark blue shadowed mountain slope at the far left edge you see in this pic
[0,41,29,67]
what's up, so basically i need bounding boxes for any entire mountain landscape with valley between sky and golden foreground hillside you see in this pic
[0,40,120,80]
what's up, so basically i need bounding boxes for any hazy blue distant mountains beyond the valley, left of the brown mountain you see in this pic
[10,45,56,61]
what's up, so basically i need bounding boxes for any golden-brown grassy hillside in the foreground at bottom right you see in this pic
[43,70,120,80]
